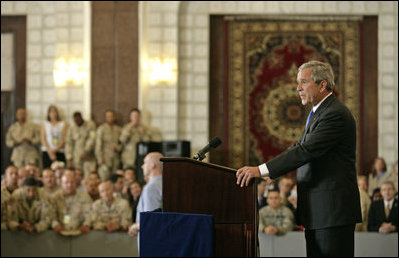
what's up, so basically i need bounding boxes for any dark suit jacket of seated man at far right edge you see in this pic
[367,200,398,232]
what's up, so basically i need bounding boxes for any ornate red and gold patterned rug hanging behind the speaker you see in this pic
[228,20,360,168]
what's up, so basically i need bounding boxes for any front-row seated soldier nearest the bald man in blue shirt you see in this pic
[91,181,132,233]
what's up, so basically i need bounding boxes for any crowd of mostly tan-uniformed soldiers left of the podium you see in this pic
[1,105,161,234]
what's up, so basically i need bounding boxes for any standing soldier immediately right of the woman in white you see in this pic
[65,112,96,178]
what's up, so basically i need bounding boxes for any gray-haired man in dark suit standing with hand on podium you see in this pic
[237,61,362,257]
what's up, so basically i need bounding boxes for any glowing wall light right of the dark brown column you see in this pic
[144,58,177,85]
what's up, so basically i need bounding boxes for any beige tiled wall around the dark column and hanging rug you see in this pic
[1,1,398,169]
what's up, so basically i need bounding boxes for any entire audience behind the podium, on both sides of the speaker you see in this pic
[1,105,398,235]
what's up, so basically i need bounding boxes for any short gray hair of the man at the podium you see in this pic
[298,60,335,91]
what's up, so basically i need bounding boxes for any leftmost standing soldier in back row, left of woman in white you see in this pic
[6,108,40,167]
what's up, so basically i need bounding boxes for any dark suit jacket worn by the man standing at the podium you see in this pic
[266,95,362,229]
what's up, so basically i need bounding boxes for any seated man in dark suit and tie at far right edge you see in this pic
[367,181,398,234]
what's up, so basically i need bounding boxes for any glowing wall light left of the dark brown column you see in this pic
[53,58,86,87]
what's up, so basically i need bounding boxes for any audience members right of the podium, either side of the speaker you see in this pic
[257,157,398,235]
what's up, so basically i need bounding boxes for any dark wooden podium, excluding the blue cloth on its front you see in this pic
[161,158,258,257]
